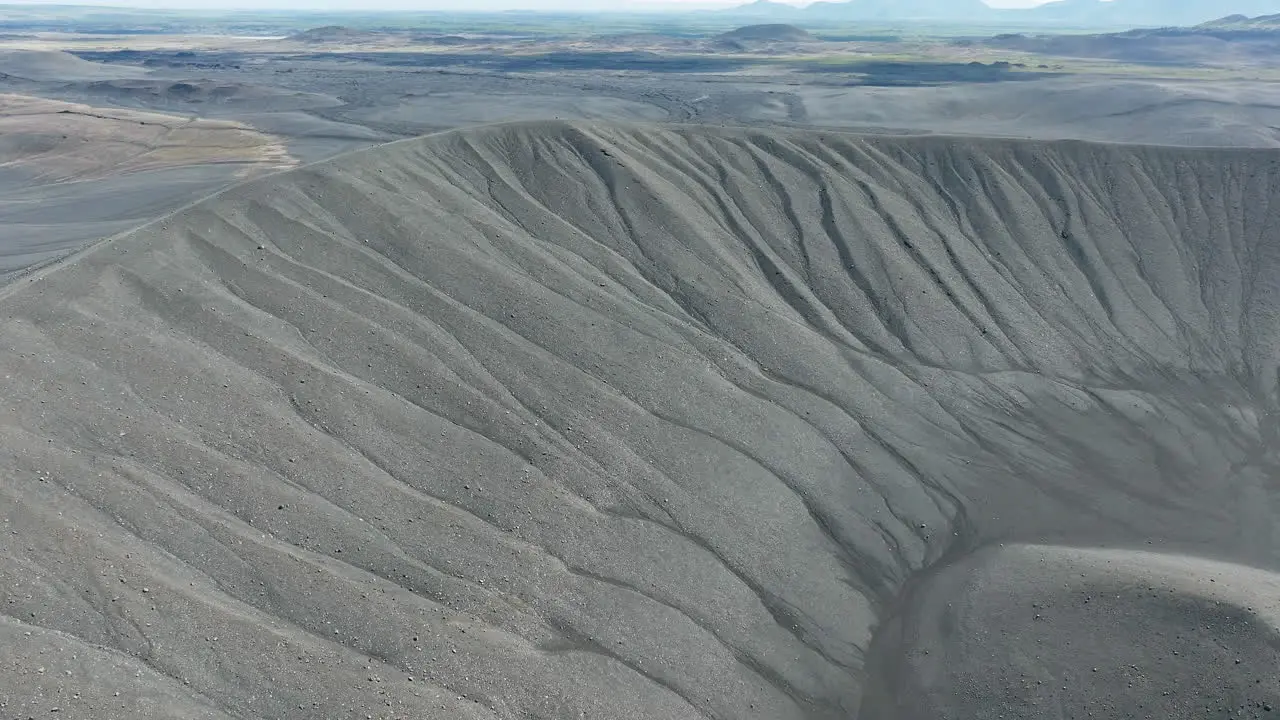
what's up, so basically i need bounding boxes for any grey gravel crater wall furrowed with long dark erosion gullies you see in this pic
[0,124,1280,719]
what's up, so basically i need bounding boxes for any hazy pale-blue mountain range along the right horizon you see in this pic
[723,0,1280,28]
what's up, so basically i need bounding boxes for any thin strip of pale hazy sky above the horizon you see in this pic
[8,0,1044,12]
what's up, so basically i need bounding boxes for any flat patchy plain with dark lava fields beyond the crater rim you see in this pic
[0,33,1280,281]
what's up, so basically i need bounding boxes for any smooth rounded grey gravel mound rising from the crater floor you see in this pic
[865,546,1280,720]
